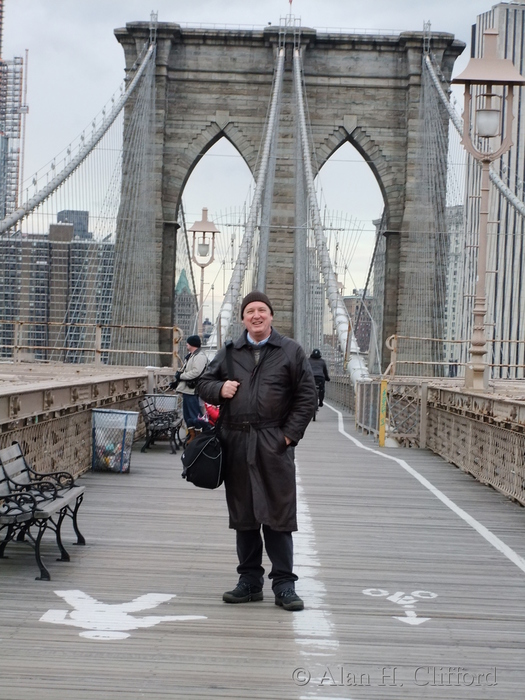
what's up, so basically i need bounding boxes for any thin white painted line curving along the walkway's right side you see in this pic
[324,401,525,573]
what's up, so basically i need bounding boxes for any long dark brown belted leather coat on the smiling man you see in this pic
[198,329,317,532]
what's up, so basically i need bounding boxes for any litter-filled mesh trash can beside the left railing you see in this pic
[91,408,139,472]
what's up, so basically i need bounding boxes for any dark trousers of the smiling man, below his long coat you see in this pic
[237,525,297,594]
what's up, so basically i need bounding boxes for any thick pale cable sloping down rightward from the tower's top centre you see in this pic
[293,48,369,386]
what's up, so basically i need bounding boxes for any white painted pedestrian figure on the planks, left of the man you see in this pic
[40,590,207,640]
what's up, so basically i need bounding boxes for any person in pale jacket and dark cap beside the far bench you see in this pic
[170,335,208,444]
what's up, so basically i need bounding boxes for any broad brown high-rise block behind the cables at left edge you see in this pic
[0,212,115,362]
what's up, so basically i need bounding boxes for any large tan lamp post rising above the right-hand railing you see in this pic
[452,29,525,391]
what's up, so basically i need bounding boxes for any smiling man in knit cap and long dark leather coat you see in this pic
[198,291,317,611]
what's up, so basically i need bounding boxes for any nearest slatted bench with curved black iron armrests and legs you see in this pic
[0,442,86,581]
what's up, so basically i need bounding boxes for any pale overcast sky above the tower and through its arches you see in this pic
[3,0,496,292]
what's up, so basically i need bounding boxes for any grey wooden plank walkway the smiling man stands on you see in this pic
[0,405,525,700]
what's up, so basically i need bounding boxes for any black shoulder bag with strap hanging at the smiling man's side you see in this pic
[181,341,233,489]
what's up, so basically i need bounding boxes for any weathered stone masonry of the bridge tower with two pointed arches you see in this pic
[115,22,464,360]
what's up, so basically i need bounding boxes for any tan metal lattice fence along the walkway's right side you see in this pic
[355,378,525,505]
